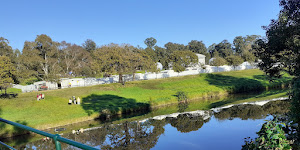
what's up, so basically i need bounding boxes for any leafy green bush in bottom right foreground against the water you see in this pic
[242,119,291,150]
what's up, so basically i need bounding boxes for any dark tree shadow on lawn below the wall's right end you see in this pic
[206,74,265,93]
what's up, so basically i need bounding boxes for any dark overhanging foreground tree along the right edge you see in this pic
[254,0,300,137]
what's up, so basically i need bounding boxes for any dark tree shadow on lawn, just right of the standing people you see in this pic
[82,94,150,119]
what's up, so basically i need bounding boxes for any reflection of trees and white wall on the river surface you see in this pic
[12,101,289,149]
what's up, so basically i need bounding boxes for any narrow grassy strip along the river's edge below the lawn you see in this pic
[2,90,287,146]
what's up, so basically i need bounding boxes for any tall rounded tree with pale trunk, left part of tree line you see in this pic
[21,34,61,81]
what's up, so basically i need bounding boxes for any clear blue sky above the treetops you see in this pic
[0,0,280,50]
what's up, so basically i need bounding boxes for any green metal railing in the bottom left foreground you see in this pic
[0,118,97,150]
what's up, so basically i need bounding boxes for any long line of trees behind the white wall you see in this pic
[0,34,259,89]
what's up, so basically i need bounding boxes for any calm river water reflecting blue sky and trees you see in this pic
[12,98,288,150]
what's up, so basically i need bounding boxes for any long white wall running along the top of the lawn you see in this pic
[13,61,257,92]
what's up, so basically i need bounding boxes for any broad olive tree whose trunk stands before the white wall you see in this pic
[93,44,155,83]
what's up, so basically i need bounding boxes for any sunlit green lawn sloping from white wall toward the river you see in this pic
[0,69,291,136]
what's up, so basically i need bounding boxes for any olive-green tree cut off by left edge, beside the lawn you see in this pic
[0,56,16,94]
